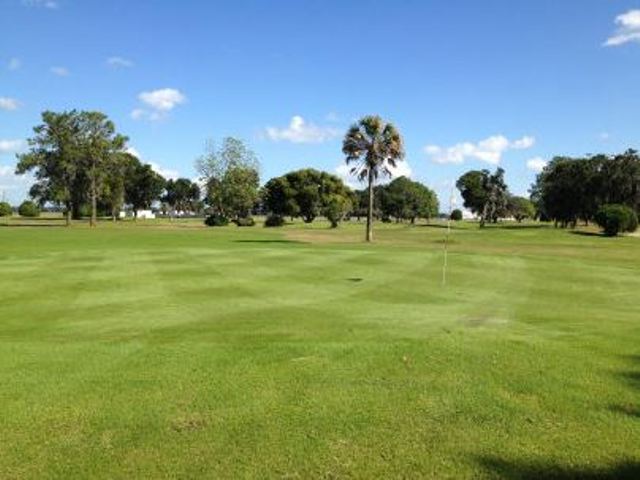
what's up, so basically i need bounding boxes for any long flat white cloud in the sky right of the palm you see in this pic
[424,135,535,165]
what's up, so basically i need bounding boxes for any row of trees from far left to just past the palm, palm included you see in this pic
[16,110,438,233]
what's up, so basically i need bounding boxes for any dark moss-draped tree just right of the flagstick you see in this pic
[456,168,509,227]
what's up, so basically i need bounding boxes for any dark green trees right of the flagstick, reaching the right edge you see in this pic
[456,150,640,234]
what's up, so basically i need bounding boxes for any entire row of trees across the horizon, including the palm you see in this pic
[16,110,640,237]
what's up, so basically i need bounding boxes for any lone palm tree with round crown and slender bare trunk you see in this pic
[342,115,404,242]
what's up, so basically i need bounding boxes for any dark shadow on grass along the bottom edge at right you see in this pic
[478,457,640,480]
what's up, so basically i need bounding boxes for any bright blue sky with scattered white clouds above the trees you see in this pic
[0,0,640,210]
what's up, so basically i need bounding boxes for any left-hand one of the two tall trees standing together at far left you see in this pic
[16,110,82,226]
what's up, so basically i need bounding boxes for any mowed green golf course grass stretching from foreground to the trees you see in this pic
[0,223,640,479]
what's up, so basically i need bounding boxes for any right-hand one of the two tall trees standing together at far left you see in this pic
[79,112,127,227]
